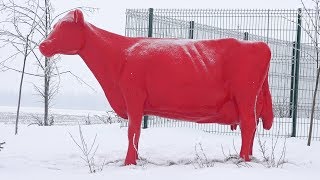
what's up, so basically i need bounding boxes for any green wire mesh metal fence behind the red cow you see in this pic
[124,8,320,140]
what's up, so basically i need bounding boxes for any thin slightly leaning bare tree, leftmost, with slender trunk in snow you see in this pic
[0,0,48,134]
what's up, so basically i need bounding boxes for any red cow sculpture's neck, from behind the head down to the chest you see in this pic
[79,24,127,114]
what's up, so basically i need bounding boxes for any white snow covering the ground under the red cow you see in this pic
[0,109,320,180]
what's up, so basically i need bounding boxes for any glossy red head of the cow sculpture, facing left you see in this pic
[39,10,85,57]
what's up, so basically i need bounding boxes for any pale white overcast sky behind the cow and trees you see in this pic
[0,0,312,110]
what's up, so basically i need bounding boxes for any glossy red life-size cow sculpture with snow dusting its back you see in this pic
[40,10,273,165]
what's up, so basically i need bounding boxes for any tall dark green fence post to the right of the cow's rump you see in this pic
[291,8,302,137]
